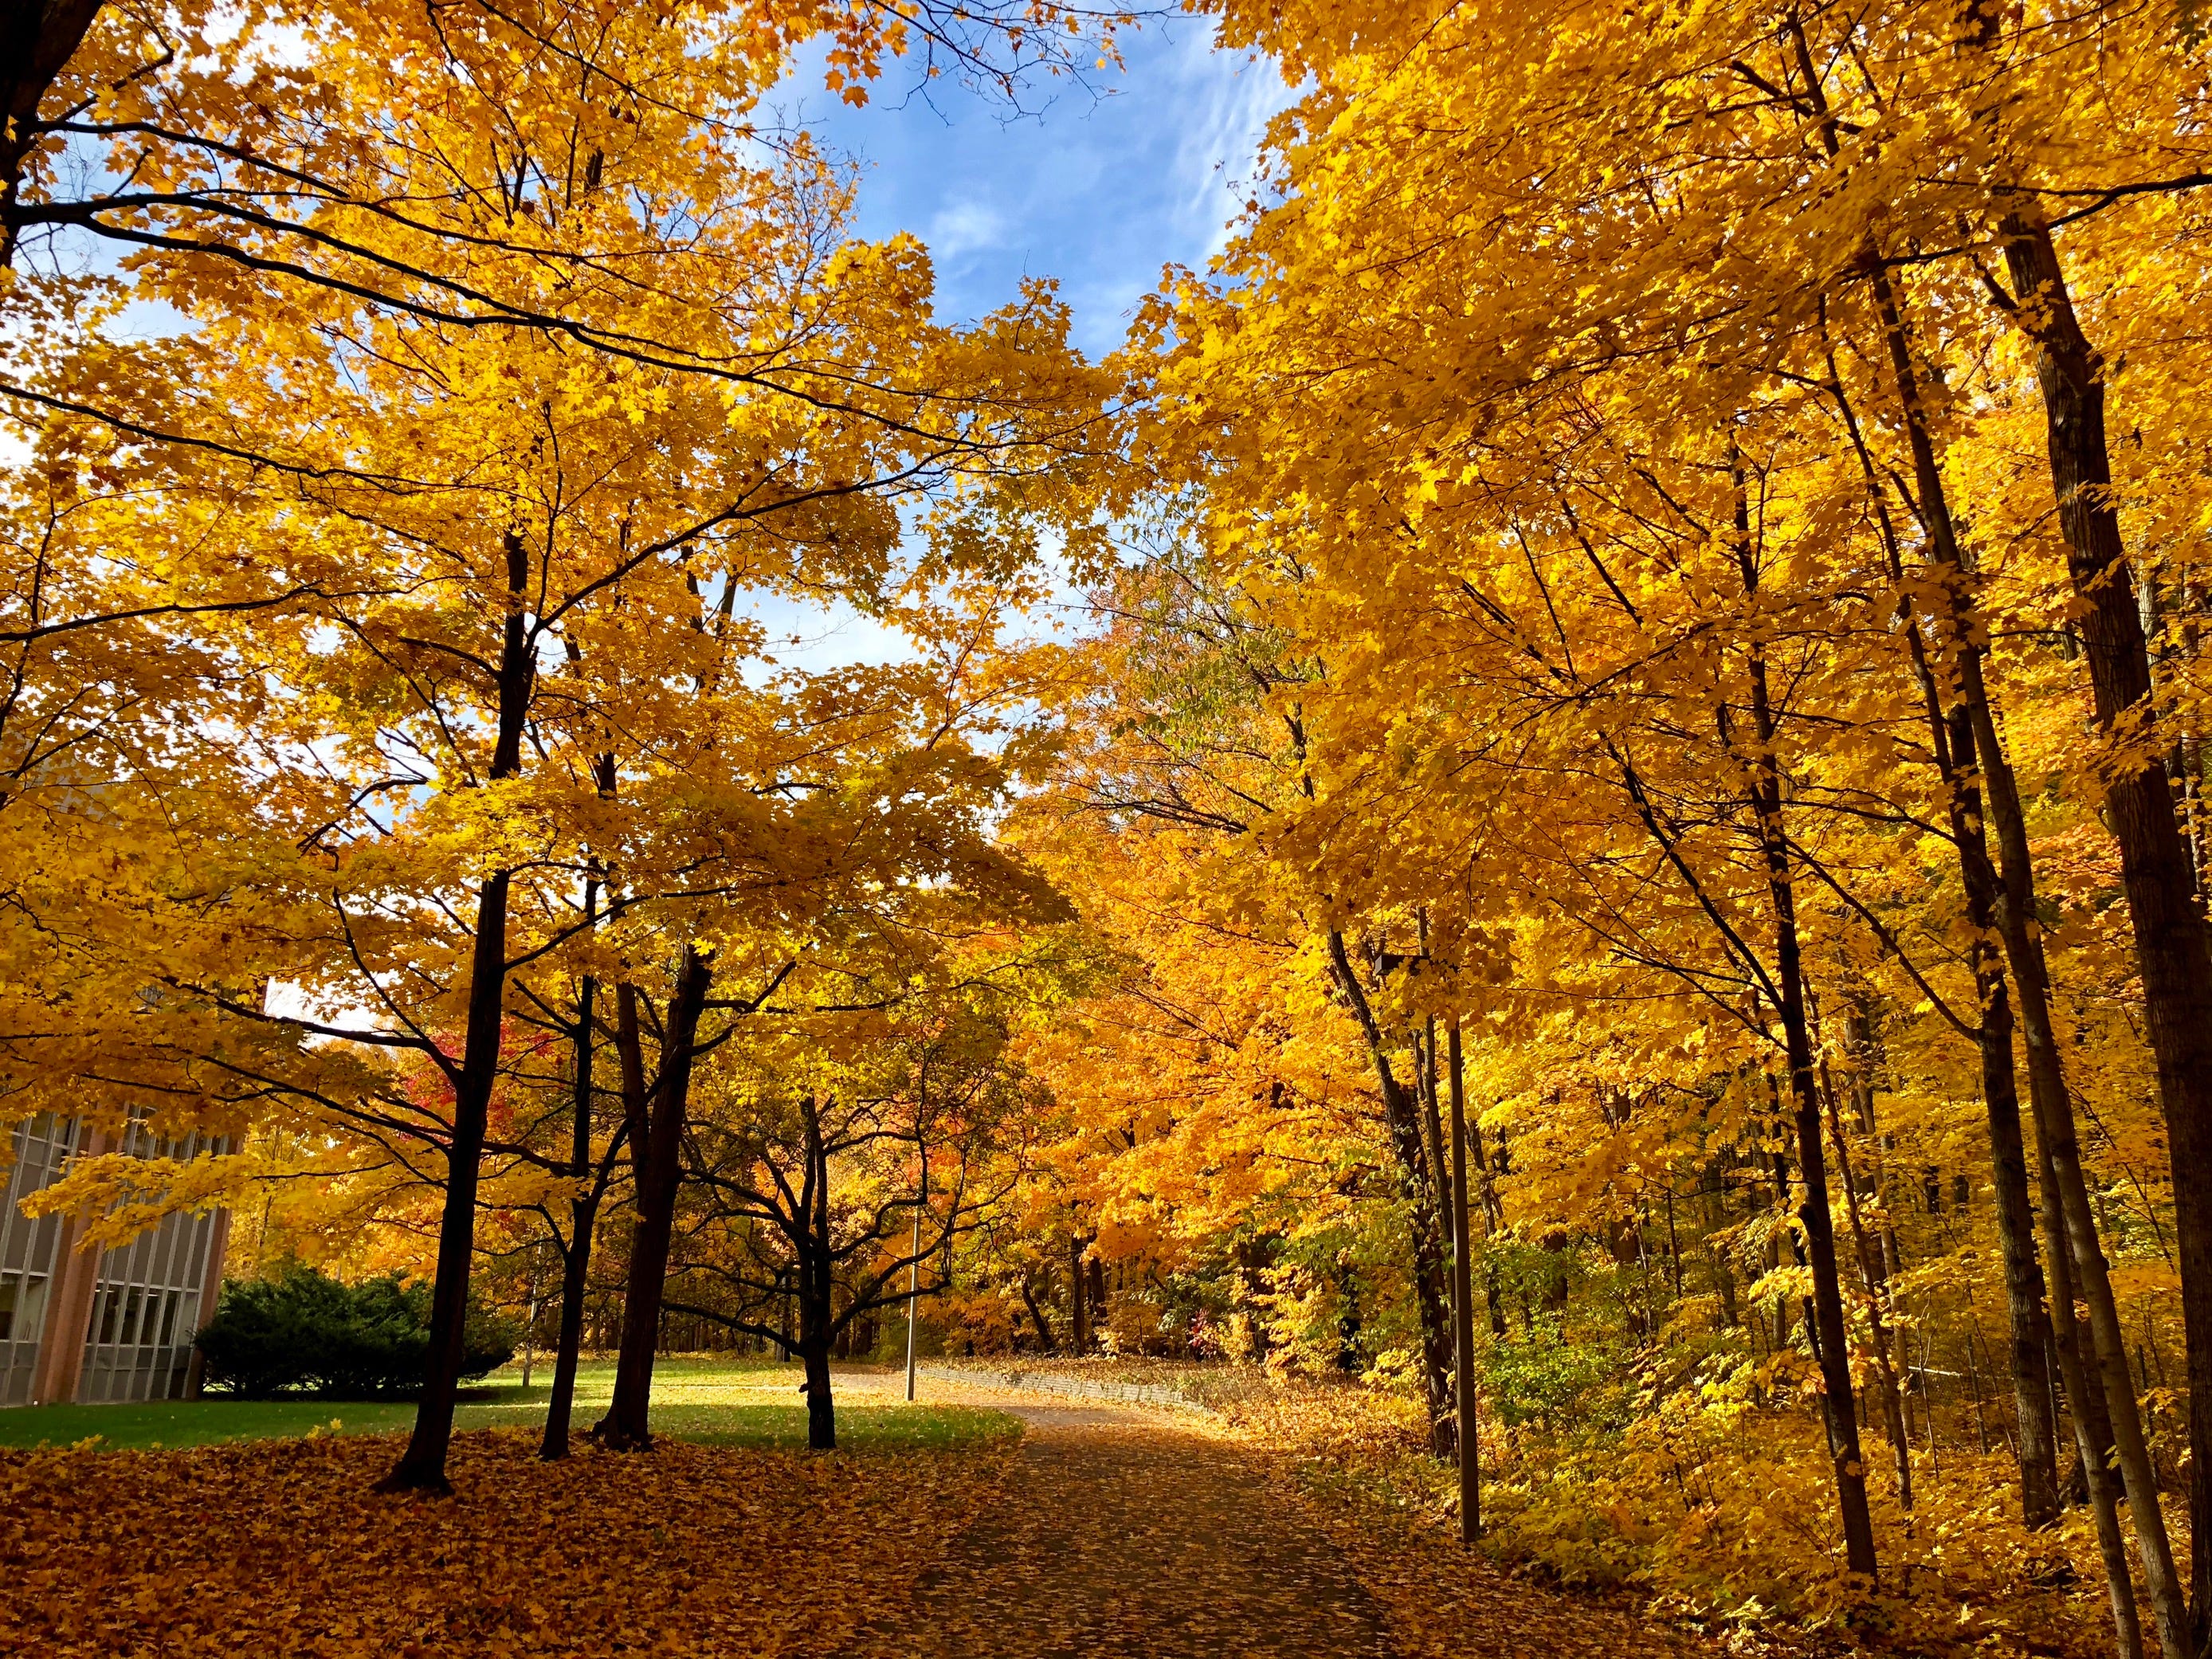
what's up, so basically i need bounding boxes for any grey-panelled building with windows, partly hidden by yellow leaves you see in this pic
[0,1112,230,1407]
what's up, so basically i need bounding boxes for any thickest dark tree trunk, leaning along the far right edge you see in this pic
[2004,224,2212,1653]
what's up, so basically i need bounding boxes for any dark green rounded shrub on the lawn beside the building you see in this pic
[197,1268,516,1400]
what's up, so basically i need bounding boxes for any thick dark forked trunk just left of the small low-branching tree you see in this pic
[593,944,715,1451]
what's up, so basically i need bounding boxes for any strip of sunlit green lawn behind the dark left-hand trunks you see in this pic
[0,1356,1022,1451]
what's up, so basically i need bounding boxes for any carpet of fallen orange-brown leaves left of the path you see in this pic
[0,1431,1009,1659]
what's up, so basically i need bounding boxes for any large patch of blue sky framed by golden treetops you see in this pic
[775,18,1289,354]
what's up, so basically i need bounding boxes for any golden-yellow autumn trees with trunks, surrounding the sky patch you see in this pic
[13,0,2212,1659]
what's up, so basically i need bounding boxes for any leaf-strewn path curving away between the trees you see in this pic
[841,1378,1710,1659]
